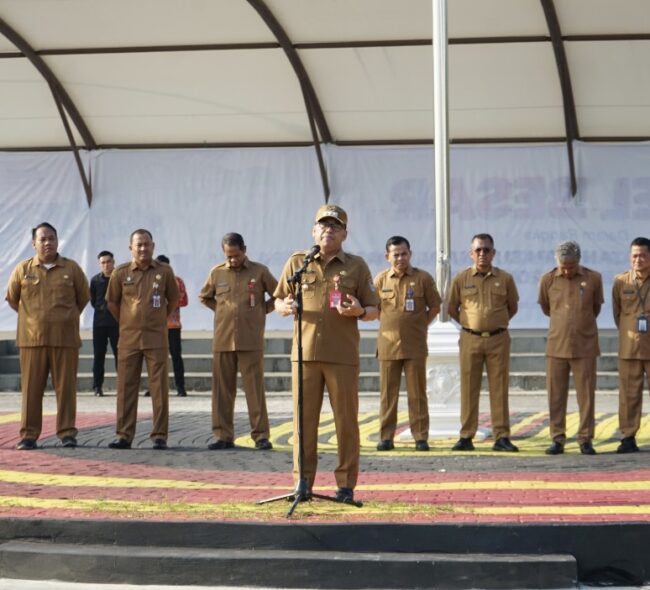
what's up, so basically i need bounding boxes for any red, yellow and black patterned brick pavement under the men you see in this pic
[0,394,650,523]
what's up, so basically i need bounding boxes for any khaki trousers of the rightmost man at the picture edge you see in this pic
[618,358,650,438]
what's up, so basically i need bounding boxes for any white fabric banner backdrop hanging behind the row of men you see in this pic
[0,143,650,330]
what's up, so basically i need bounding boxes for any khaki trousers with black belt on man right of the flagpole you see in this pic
[460,331,510,440]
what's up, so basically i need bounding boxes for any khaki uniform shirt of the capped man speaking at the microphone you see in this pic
[274,250,379,365]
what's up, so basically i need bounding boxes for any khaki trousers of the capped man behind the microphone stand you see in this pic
[291,361,360,489]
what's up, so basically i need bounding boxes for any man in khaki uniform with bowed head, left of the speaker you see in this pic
[199,233,278,450]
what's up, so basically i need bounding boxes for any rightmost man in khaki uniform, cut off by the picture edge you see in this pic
[612,238,650,453]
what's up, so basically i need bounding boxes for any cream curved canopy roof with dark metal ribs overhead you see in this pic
[0,0,650,150]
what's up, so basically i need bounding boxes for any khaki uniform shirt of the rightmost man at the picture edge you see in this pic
[612,270,650,360]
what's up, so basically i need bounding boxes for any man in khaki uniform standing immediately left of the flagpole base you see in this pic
[375,236,441,451]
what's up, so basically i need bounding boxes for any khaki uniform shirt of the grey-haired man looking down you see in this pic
[537,266,604,358]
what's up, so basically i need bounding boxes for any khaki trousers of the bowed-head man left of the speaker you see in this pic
[212,350,270,442]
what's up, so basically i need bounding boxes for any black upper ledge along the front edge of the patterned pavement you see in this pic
[0,518,650,588]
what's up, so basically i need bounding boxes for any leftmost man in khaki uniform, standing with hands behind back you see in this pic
[6,223,90,451]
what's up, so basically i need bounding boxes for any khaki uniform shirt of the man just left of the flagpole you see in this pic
[375,267,441,360]
